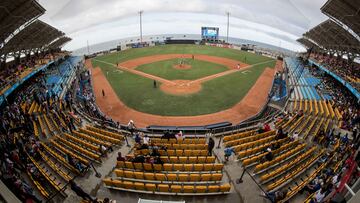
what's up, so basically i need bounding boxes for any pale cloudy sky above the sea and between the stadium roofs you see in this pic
[39,0,327,51]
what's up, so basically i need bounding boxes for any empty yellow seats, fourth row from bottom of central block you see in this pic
[160,156,215,164]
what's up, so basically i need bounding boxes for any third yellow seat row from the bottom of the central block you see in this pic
[117,161,224,172]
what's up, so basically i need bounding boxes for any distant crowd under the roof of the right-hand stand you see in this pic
[311,53,360,90]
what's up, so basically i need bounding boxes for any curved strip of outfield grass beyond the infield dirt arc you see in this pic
[96,44,270,64]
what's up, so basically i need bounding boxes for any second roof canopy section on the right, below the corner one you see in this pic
[304,19,360,54]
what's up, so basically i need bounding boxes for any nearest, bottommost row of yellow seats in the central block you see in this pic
[103,178,231,195]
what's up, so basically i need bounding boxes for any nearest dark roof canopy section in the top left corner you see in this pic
[0,0,45,44]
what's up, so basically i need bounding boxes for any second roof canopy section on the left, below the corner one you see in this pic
[0,20,64,55]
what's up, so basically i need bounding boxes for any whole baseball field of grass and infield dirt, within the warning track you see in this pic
[90,45,276,125]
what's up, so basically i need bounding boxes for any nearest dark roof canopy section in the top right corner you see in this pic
[321,0,360,36]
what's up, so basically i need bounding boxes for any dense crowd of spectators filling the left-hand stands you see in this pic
[0,55,84,202]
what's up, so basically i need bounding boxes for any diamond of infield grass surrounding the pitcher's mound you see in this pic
[136,59,228,80]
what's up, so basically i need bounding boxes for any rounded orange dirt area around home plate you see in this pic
[160,80,201,96]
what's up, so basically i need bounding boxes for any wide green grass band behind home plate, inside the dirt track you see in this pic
[92,58,275,116]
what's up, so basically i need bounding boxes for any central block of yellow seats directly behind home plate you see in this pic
[103,138,231,195]
